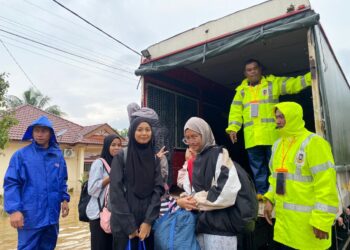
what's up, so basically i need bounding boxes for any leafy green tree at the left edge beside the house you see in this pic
[0,73,18,149]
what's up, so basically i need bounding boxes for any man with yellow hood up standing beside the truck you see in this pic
[264,102,338,250]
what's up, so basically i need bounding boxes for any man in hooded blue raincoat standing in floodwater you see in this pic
[4,116,70,249]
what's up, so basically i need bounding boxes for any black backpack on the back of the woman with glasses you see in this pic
[228,162,259,234]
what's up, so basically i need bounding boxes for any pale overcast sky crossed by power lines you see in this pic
[0,0,350,129]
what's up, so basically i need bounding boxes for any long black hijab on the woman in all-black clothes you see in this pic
[125,117,156,199]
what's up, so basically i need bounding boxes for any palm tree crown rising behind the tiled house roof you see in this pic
[6,87,65,116]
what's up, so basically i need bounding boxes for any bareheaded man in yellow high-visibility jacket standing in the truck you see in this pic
[226,59,311,200]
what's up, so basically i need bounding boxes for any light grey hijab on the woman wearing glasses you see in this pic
[184,117,216,152]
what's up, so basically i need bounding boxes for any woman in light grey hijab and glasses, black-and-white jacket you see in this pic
[177,117,241,250]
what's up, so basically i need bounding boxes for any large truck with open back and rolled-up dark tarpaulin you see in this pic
[135,0,350,249]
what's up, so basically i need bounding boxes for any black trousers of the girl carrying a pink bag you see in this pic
[89,219,113,250]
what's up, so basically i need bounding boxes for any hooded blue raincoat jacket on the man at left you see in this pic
[4,116,70,229]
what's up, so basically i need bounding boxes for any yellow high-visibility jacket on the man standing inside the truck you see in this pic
[226,73,311,148]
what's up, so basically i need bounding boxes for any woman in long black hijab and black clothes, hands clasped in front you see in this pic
[110,117,164,250]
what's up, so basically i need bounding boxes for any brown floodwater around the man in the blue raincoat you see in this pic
[0,193,90,250]
